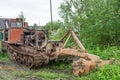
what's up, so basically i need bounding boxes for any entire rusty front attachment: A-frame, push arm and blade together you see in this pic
[57,30,115,76]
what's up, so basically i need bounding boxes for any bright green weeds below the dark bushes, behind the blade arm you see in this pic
[88,46,120,60]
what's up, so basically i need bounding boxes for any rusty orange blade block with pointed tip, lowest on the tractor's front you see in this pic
[72,58,115,76]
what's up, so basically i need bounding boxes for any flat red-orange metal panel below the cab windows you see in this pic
[9,28,23,43]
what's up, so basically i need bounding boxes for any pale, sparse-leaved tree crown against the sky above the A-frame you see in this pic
[59,0,85,31]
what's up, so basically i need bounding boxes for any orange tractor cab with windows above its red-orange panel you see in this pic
[7,18,24,44]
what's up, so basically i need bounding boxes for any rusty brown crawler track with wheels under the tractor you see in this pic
[8,45,49,68]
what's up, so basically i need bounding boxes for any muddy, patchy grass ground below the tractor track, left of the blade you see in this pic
[0,61,74,80]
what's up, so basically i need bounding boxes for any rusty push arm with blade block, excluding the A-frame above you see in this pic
[58,48,115,76]
